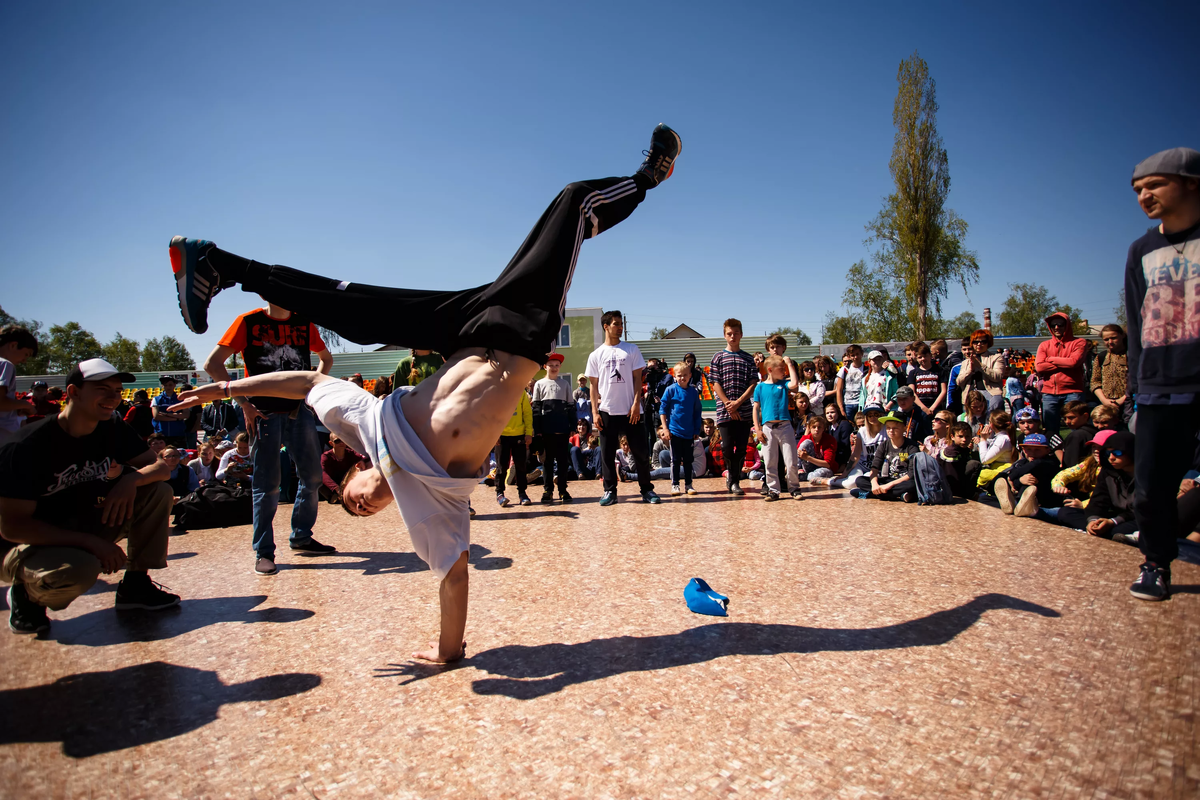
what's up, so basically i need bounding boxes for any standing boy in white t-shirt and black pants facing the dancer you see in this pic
[586,311,660,506]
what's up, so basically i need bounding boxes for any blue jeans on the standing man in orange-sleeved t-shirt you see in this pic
[251,405,322,560]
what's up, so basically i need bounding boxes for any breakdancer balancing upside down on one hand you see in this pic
[170,125,683,662]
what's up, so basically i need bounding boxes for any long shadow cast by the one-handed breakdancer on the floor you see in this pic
[377,594,1060,700]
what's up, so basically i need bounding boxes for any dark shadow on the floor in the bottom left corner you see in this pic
[0,661,320,758]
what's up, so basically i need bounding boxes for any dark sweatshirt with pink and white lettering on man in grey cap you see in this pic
[1126,219,1200,403]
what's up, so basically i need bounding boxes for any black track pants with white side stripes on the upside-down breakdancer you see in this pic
[228,174,650,363]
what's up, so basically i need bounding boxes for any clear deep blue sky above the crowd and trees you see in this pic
[0,2,1200,362]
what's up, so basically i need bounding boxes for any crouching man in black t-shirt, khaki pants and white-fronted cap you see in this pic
[0,359,179,633]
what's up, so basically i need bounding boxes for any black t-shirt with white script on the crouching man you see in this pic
[0,414,149,524]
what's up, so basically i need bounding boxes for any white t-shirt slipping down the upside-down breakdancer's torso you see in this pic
[307,380,479,578]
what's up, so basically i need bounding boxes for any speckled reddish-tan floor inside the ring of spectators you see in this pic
[0,480,1200,799]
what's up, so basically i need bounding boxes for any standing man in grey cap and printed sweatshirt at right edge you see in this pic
[1124,148,1200,600]
